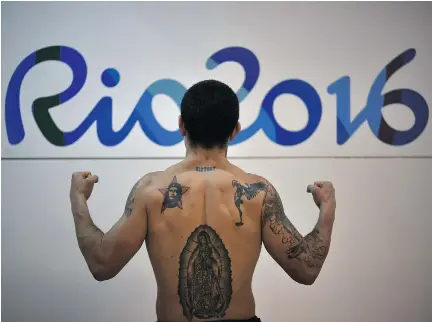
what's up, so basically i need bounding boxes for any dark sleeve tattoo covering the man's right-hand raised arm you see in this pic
[263,184,328,268]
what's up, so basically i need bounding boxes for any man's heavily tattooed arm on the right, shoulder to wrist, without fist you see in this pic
[262,181,334,285]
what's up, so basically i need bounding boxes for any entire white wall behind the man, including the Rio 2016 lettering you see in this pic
[1,2,432,322]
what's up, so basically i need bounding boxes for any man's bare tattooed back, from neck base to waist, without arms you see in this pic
[142,162,266,321]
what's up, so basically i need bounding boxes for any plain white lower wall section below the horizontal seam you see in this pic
[2,160,432,322]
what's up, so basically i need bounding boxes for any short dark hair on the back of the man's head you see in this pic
[181,80,239,149]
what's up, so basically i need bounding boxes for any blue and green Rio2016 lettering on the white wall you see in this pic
[5,46,429,146]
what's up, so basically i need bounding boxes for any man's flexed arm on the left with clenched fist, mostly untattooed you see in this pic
[70,172,147,281]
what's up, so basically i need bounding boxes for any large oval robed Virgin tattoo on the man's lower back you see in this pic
[178,225,232,321]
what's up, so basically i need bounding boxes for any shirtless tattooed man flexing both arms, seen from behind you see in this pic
[70,81,336,322]
